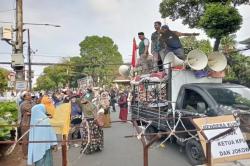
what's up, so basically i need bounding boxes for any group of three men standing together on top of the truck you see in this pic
[137,21,199,73]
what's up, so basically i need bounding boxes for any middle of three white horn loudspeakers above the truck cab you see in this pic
[185,49,208,70]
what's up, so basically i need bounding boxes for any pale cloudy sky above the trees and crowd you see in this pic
[0,0,250,83]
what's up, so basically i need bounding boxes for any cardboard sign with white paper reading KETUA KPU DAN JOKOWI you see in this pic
[193,115,250,163]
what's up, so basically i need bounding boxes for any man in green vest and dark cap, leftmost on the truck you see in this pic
[138,32,150,73]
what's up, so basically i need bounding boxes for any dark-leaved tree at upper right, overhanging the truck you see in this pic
[160,0,249,50]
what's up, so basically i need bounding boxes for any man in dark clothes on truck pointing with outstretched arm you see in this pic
[160,25,199,61]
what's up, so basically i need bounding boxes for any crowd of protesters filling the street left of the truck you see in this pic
[17,87,131,166]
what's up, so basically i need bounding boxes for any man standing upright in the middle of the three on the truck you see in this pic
[151,21,161,71]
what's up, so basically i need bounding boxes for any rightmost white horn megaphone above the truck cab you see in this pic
[208,52,227,72]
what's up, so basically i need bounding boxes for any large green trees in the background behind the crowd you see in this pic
[36,36,122,90]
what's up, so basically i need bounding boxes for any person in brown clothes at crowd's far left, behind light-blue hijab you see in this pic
[20,91,35,159]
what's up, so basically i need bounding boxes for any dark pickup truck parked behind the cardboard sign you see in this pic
[131,77,250,165]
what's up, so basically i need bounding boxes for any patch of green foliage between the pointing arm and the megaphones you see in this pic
[181,36,212,55]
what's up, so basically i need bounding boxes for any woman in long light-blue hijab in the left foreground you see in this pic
[28,104,57,166]
